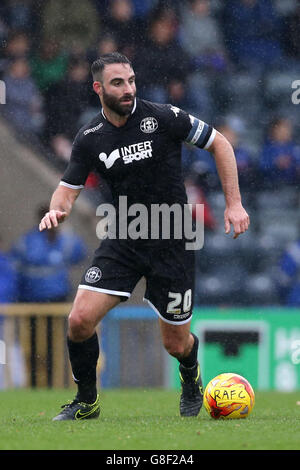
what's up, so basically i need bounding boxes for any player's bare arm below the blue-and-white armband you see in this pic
[207,131,250,238]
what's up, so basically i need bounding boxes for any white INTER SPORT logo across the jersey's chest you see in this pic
[99,140,152,169]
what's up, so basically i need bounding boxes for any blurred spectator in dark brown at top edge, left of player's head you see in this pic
[41,0,100,51]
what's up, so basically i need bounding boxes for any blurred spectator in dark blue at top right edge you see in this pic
[223,0,282,72]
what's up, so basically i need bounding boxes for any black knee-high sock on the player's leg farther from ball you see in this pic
[67,333,99,403]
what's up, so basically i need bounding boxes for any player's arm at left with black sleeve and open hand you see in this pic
[39,132,92,231]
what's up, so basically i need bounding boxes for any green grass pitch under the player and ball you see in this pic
[0,389,300,451]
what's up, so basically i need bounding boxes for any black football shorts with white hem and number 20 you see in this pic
[79,239,195,325]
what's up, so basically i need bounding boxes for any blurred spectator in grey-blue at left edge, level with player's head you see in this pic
[3,58,44,134]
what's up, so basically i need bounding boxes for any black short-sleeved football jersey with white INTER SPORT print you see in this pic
[60,99,216,210]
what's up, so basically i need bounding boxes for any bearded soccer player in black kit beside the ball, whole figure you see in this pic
[39,53,249,420]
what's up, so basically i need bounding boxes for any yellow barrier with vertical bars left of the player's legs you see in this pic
[0,303,73,388]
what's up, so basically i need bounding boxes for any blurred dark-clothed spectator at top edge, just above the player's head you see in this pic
[103,0,143,60]
